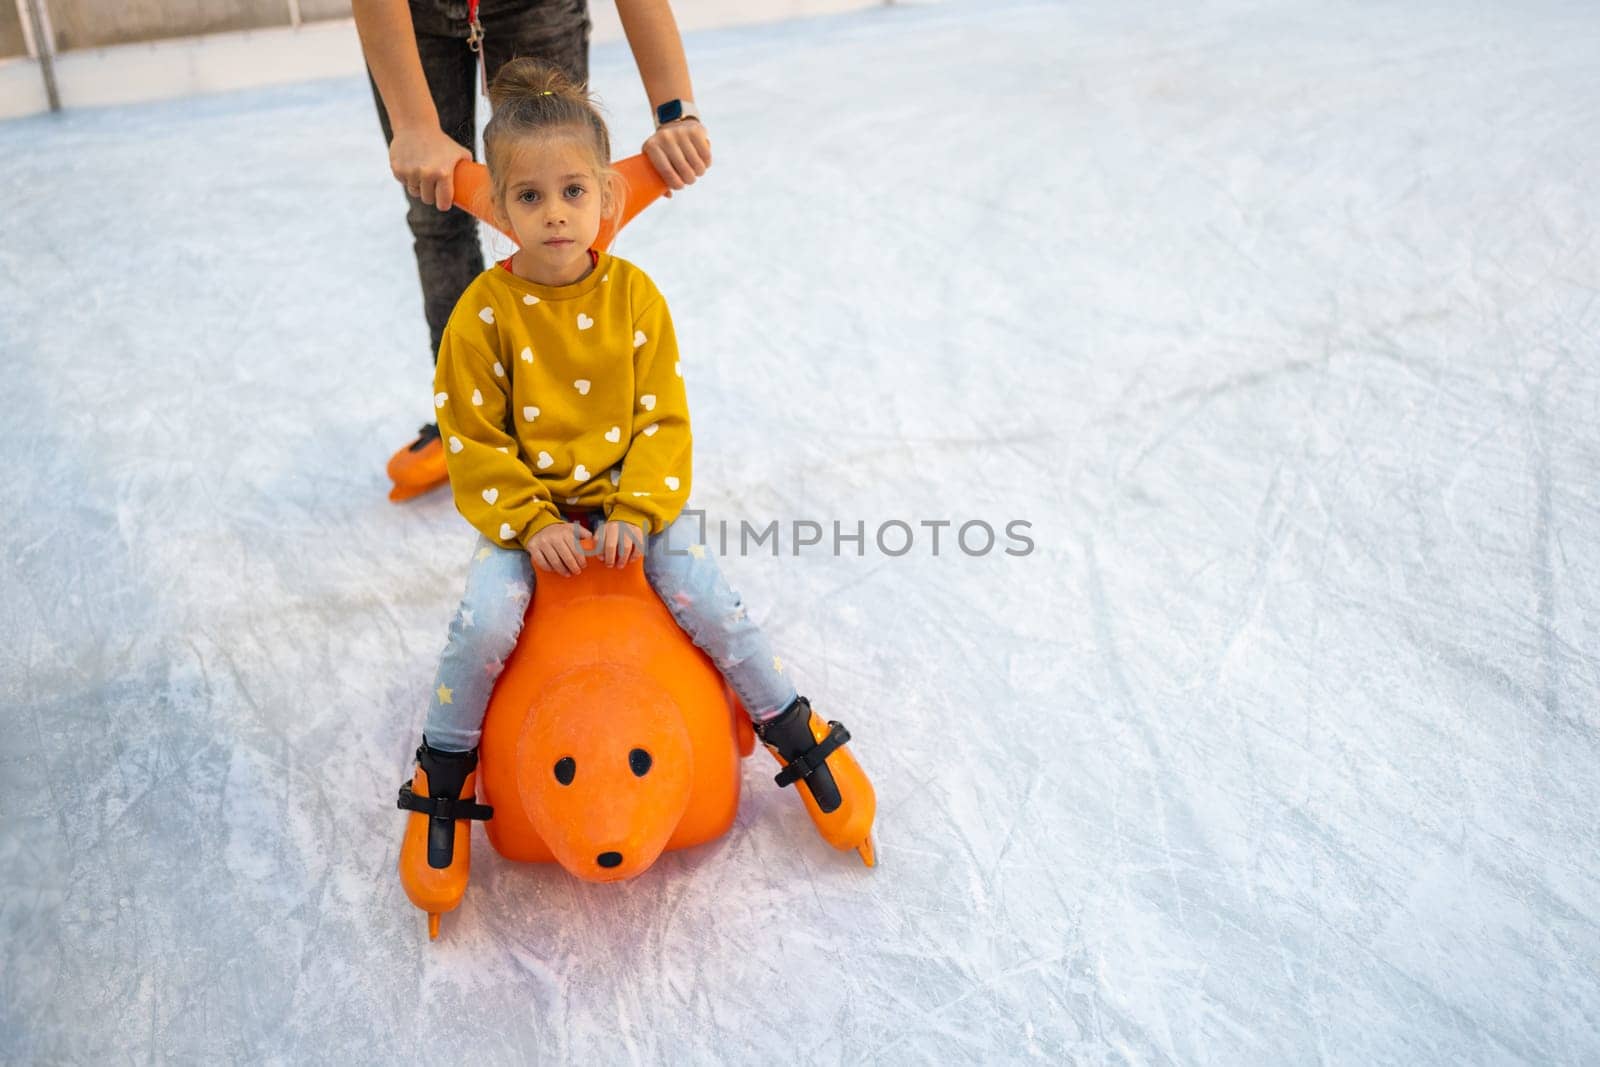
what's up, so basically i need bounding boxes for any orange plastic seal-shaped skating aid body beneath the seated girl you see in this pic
[478,539,755,881]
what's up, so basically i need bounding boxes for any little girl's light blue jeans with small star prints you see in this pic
[422,514,797,752]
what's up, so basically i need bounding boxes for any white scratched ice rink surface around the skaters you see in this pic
[0,0,1600,1064]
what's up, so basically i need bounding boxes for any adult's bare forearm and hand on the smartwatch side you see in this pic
[616,0,710,189]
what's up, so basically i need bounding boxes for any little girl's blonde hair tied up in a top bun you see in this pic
[483,58,622,219]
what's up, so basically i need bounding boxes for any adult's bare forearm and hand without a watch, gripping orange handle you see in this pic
[350,0,470,211]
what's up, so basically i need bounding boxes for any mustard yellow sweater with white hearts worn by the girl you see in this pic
[434,253,693,545]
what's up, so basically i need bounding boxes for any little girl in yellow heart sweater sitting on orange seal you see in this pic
[400,59,874,912]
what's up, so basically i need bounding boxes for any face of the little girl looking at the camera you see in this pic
[499,136,605,285]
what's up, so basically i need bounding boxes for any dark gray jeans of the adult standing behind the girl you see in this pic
[368,0,589,362]
